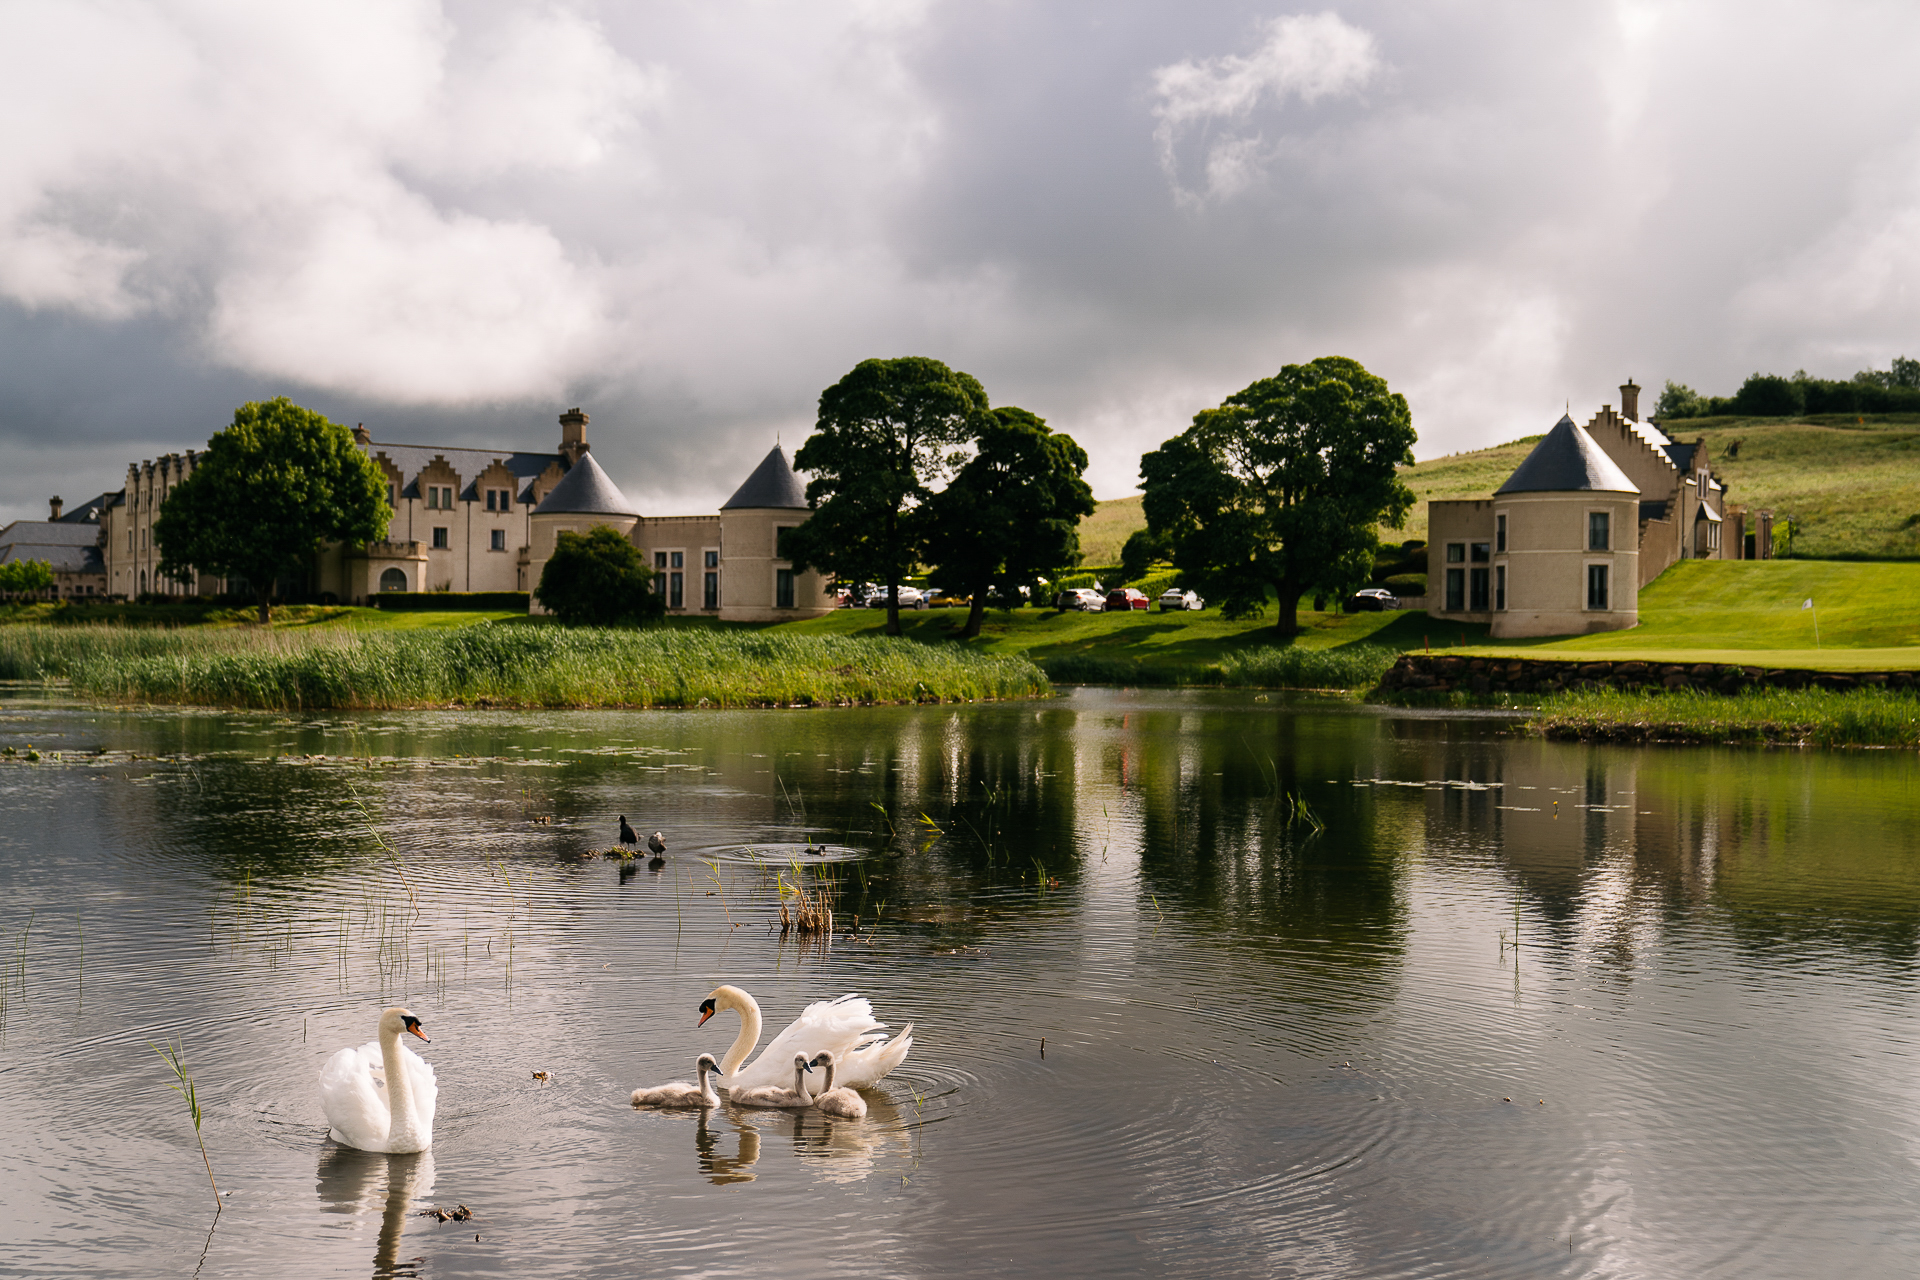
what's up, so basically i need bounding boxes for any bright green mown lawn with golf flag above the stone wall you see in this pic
[1473,560,1920,672]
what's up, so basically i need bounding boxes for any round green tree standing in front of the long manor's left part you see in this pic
[154,395,394,622]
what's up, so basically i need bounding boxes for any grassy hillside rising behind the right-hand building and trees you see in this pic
[1081,415,1920,564]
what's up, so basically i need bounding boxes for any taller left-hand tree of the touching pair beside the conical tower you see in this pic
[783,355,987,635]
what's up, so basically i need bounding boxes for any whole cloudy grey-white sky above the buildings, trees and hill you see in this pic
[0,0,1920,518]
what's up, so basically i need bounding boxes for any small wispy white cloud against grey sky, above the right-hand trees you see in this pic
[1154,12,1380,203]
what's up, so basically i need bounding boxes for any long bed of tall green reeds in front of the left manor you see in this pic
[0,624,1048,710]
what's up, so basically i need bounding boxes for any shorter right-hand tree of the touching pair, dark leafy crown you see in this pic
[925,407,1094,637]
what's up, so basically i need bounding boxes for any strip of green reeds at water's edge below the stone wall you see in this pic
[1526,689,1920,748]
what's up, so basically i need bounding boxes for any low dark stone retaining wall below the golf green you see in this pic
[1380,652,1920,693]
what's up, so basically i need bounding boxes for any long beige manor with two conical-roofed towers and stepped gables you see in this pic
[98,409,833,622]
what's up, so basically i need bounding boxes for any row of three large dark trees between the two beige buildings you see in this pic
[787,357,1415,635]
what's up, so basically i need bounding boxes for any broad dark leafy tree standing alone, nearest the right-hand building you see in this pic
[1140,355,1413,635]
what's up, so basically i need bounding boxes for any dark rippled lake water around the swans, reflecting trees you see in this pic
[0,689,1920,1278]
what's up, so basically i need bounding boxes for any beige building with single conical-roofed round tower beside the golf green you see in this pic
[1427,380,1772,637]
